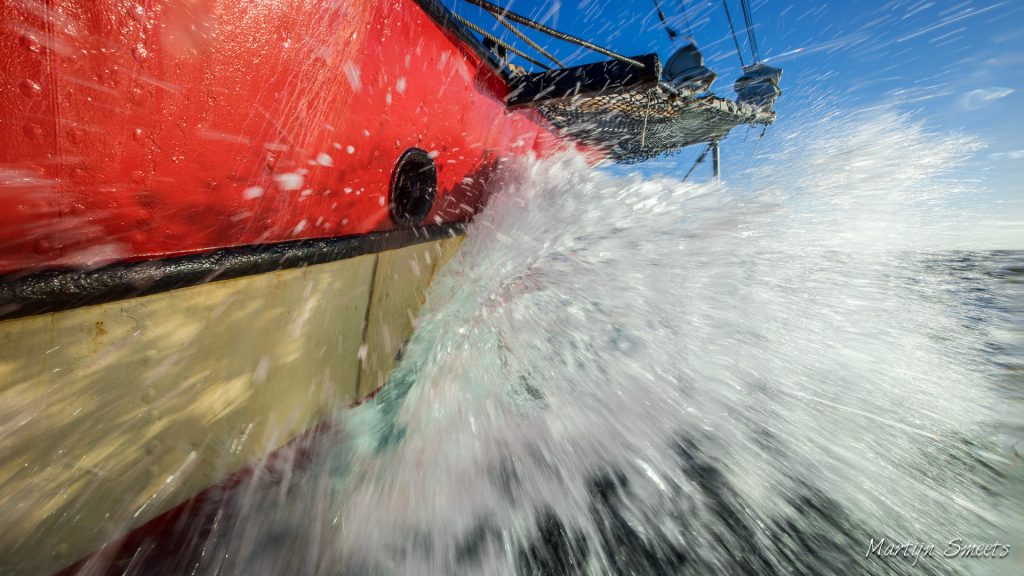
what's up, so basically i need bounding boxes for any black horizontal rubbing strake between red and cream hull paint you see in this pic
[0,223,465,321]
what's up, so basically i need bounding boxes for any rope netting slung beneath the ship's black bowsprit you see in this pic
[538,87,775,164]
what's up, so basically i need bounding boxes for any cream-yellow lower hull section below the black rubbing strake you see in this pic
[0,231,459,574]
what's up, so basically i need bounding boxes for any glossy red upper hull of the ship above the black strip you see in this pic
[0,0,561,274]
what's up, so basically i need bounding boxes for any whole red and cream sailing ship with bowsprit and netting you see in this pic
[0,0,780,574]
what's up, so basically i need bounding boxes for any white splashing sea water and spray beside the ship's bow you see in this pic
[119,113,1024,575]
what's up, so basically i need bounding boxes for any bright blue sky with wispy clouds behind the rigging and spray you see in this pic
[444,0,1024,247]
